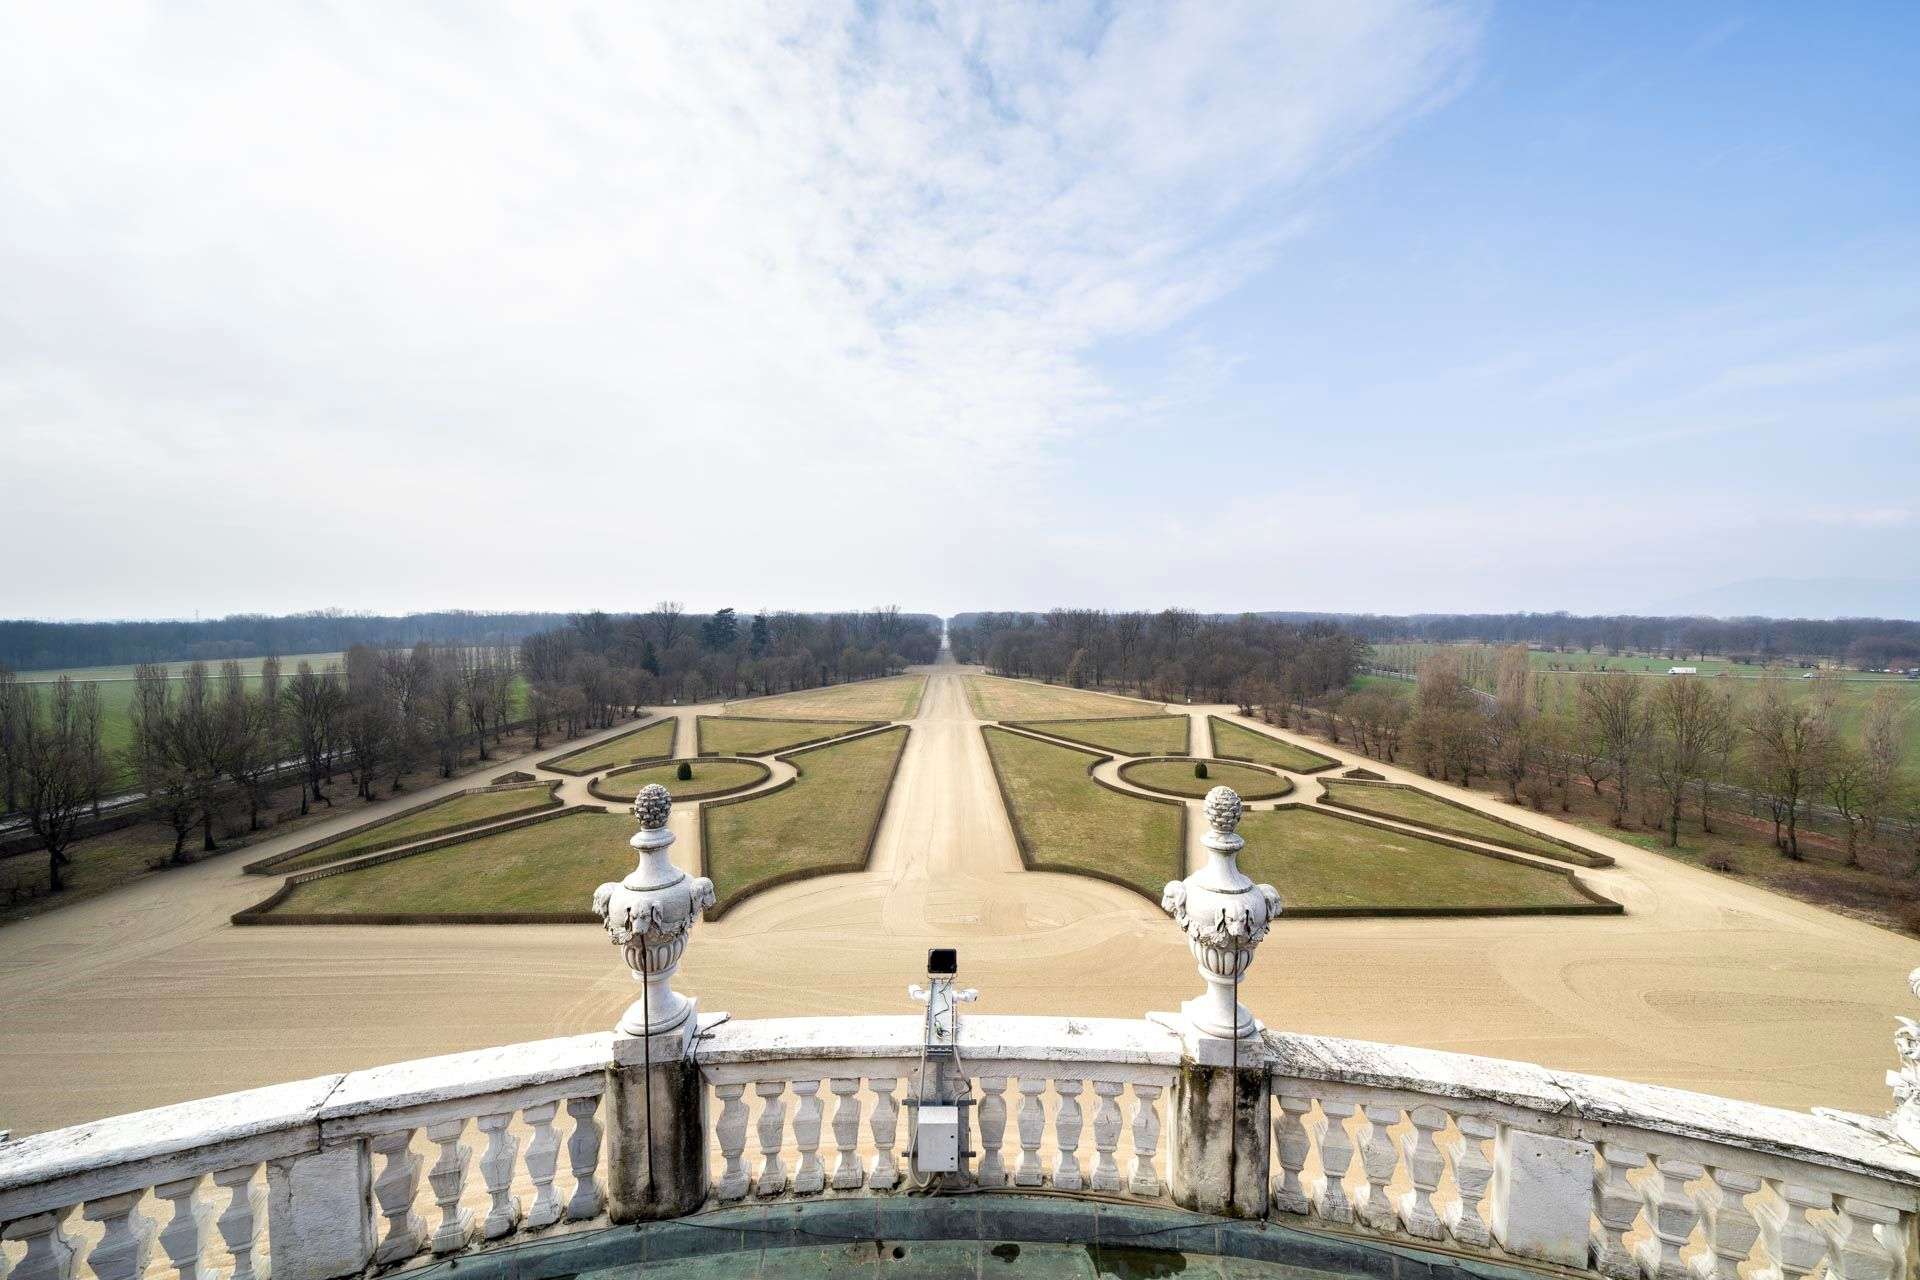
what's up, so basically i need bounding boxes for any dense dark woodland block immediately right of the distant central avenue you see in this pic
[948,608,1367,708]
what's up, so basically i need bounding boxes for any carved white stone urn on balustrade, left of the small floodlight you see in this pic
[593,783,714,1036]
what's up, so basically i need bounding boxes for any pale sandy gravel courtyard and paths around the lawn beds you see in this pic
[0,664,1920,1132]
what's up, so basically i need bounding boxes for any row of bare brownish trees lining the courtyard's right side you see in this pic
[1328,645,1920,865]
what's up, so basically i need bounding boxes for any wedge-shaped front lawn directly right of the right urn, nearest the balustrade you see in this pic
[1240,806,1590,919]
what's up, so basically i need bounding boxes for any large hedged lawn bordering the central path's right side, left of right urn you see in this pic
[981,725,1187,902]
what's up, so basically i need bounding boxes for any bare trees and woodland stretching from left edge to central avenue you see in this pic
[0,603,941,890]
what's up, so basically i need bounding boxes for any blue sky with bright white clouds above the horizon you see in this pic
[0,0,1920,618]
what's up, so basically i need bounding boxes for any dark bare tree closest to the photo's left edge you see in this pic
[10,676,106,892]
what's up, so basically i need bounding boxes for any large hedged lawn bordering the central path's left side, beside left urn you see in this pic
[701,727,906,912]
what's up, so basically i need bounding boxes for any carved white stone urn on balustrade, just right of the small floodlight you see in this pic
[1160,787,1281,1040]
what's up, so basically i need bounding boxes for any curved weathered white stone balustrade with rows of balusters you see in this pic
[0,1015,1920,1280]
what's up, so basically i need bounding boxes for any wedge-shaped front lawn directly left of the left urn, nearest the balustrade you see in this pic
[255,812,636,917]
